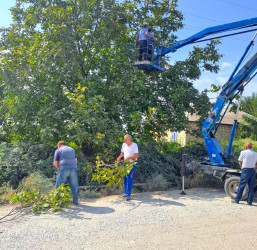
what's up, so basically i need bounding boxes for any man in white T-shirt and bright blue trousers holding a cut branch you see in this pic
[117,135,139,201]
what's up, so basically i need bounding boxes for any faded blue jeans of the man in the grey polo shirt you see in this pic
[56,168,79,204]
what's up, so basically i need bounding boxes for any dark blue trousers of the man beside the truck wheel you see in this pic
[235,168,256,204]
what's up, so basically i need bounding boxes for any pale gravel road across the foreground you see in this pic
[0,188,257,250]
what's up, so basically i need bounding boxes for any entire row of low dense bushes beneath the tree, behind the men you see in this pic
[0,142,207,193]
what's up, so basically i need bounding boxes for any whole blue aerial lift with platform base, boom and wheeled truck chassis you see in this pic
[135,18,257,198]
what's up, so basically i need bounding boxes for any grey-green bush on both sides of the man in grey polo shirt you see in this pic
[0,143,95,189]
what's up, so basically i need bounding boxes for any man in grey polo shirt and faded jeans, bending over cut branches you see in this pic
[53,141,78,205]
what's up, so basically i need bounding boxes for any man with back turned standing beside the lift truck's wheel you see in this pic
[232,142,257,205]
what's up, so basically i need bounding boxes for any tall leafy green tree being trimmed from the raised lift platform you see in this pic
[0,0,221,158]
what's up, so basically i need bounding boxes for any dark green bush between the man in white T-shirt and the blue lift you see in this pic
[135,142,207,187]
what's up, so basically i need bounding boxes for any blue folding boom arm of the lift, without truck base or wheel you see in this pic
[145,18,257,166]
